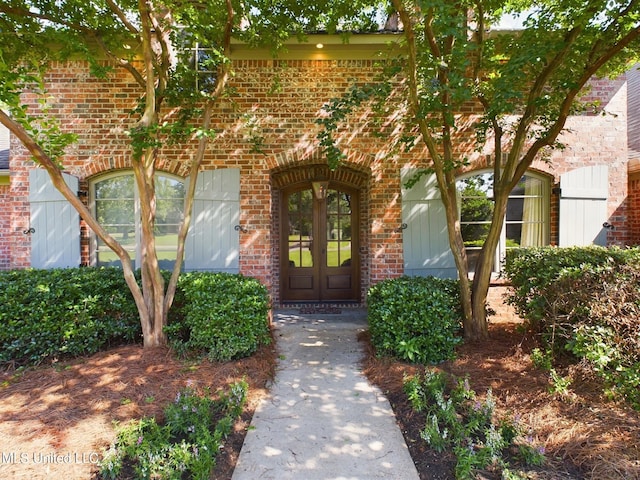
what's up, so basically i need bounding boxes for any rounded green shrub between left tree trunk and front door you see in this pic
[166,272,271,361]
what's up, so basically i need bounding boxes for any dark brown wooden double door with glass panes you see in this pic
[281,184,360,302]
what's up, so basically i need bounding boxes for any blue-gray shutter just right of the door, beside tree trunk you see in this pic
[400,169,458,278]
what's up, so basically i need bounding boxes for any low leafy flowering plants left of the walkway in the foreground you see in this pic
[99,381,248,480]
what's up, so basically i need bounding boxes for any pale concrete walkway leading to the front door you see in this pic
[233,309,418,480]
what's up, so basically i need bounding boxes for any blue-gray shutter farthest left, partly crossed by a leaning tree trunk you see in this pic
[29,168,80,268]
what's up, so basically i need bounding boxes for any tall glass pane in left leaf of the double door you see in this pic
[287,190,313,267]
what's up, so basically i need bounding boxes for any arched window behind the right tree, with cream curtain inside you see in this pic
[457,172,549,272]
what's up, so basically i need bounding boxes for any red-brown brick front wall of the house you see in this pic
[5,56,628,301]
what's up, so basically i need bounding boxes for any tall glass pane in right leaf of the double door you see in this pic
[327,190,351,267]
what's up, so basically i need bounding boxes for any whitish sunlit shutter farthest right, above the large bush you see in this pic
[559,165,609,247]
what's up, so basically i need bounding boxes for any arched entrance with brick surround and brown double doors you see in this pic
[271,163,371,303]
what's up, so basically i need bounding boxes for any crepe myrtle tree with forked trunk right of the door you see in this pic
[319,0,640,340]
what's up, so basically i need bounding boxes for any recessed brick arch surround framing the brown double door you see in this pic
[270,158,371,304]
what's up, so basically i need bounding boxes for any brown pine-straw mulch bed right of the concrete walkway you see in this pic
[363,321,640,480]
